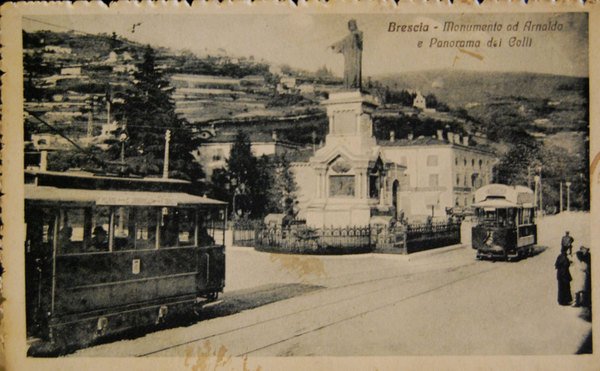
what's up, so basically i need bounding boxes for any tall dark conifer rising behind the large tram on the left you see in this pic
[110,46,204,181]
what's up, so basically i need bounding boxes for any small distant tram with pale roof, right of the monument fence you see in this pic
[471,184,537,260]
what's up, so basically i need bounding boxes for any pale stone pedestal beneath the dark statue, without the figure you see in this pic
[305,90,386,227]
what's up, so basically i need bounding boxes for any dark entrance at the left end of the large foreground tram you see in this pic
[25,207,56,336]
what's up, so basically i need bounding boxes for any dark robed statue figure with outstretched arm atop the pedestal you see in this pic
[331,19,363,90]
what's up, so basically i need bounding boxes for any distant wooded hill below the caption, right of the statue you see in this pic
[377,71,589,140]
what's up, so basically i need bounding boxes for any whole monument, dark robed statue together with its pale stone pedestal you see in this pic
[305,20,405,227]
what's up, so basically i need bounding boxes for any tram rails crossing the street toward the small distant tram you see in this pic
[137,261,502,357]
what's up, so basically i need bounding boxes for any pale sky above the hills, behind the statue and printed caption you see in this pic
[23,13,588,77]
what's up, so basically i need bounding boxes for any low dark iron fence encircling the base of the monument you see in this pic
[232,220,460,254]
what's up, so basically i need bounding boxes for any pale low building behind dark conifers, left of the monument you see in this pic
[193,131,302,178]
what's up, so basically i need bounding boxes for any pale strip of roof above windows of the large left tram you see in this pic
[25,184,225,206]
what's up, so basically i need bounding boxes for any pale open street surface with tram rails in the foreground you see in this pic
[71,213,591,357]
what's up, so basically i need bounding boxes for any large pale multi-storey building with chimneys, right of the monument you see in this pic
[378,130,498,220]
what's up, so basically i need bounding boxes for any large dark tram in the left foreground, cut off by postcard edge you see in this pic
[25,171,226,353]
